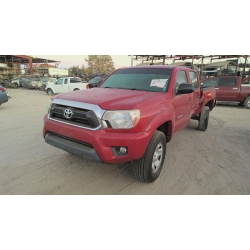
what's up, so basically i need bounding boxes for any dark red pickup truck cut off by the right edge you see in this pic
[201,76,250,109]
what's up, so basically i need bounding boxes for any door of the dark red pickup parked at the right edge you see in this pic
[218,77,240,101]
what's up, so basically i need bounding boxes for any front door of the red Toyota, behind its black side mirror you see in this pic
[174,70,193,133]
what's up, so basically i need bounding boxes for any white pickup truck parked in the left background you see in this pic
[45,77,88,95]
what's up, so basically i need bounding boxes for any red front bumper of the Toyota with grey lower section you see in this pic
[43,115,154,163]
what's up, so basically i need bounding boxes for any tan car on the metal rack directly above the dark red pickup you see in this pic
[201,61,242,76]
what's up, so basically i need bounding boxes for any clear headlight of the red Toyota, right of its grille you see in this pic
[102,109,140,129]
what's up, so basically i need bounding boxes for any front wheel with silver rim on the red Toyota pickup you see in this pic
[132,130,167,182]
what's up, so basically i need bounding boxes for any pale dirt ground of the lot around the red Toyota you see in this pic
[0,89,250,194]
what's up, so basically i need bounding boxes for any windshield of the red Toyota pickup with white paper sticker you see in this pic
[100,68,172,92]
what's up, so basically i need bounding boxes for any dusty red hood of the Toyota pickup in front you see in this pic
[53,88,164,110]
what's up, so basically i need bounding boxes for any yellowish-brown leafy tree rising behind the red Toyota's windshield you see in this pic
[85,55,115,75]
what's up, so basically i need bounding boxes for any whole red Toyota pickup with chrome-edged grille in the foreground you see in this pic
[43,65,216,182]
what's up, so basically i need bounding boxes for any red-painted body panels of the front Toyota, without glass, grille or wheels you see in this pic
[43,65,215,163]
